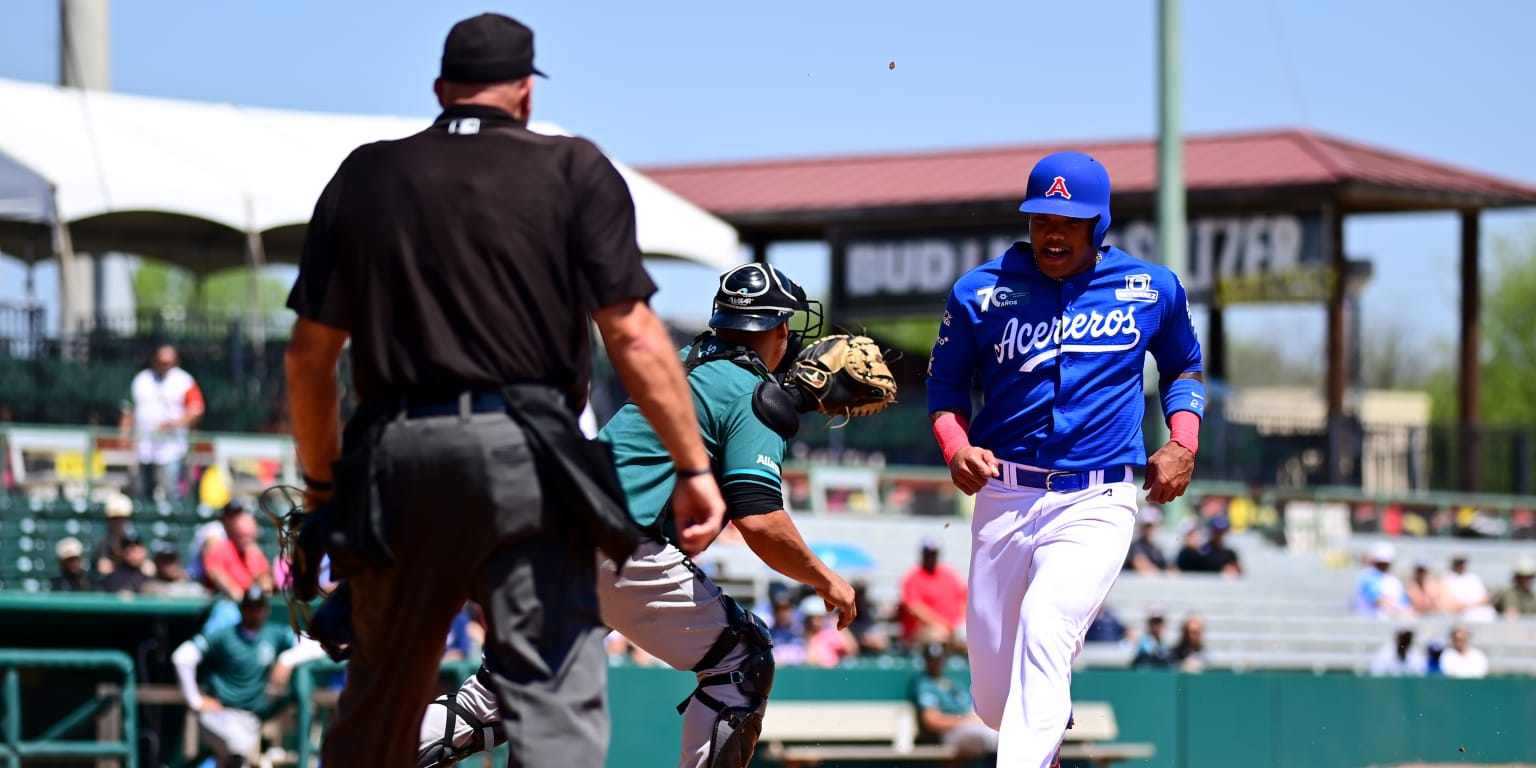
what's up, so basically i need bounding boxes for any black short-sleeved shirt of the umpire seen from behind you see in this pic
[289,106,656,402]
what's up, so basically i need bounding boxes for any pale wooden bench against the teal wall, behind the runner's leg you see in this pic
[759,700,1155,768]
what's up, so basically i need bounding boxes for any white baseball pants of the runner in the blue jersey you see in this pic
[966,468,1137,768]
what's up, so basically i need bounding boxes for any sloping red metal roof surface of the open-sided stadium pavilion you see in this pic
[642,129,1536,217]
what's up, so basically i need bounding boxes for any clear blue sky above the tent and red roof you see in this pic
[0,0,1536,359]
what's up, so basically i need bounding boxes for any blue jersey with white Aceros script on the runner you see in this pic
[928,243,1204,470]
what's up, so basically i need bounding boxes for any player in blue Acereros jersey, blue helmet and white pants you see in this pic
[928,152,1206,768]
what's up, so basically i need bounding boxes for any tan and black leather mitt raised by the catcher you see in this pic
[783,333,895,416]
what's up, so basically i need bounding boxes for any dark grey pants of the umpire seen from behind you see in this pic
[323,413,608,768]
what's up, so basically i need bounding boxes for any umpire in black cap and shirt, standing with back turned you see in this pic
[286,14,725,768]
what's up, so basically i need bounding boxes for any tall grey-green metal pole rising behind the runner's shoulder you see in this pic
[1152,0,1189,521]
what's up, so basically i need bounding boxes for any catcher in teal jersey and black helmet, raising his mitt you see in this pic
[419,264,895,768]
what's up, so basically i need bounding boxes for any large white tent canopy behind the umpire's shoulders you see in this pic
[0,80,740,273]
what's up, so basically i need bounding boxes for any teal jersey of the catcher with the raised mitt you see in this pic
[598,336,785,538]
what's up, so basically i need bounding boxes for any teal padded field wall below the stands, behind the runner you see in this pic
[607,667,1536,768]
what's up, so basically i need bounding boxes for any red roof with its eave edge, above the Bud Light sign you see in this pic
[644,129,1536,237]
